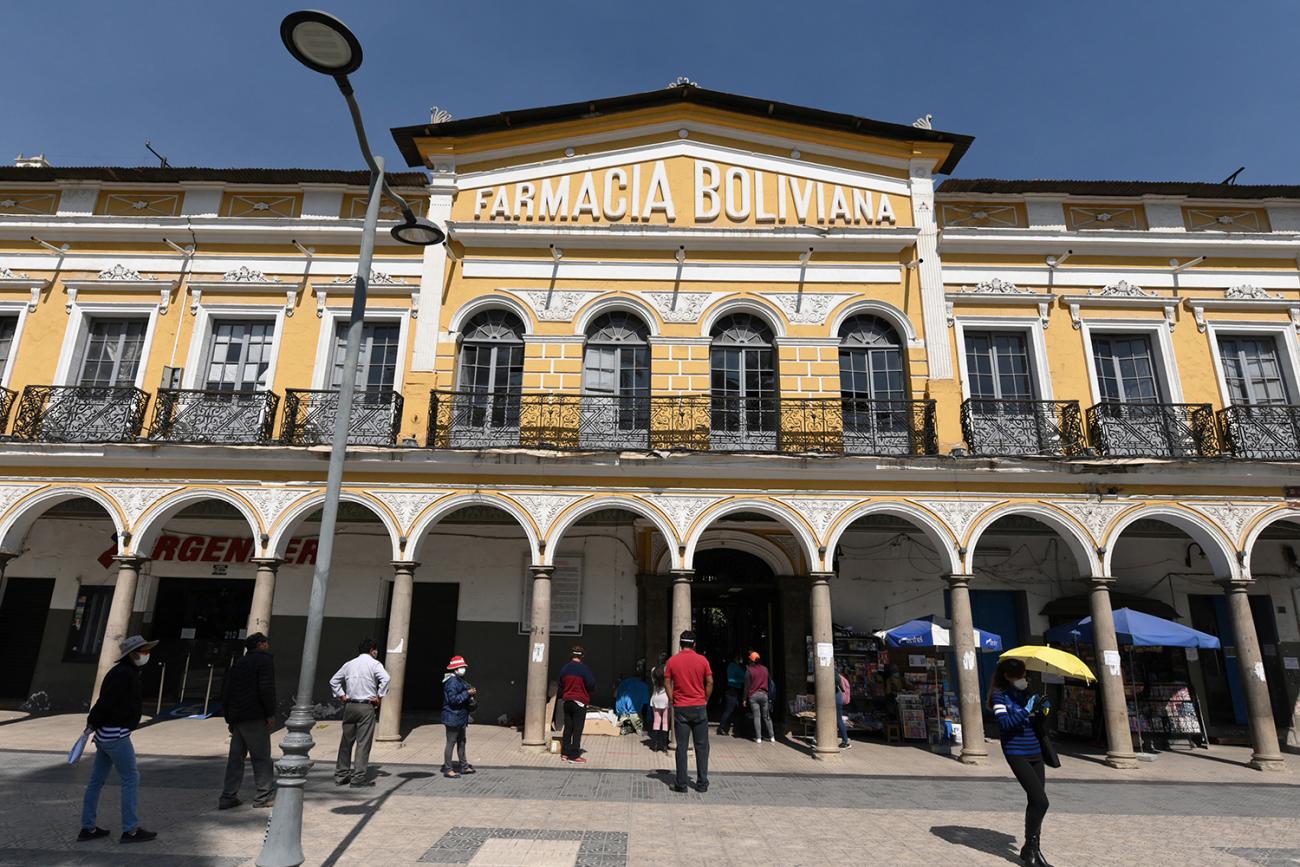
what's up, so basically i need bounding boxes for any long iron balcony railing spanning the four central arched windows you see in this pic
[428,391,937,455]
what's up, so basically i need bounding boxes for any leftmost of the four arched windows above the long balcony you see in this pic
[449,309,524,448]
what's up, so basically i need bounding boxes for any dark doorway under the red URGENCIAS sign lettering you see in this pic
[143,578,254,714]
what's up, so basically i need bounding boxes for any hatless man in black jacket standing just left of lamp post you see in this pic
[217,632,276,810]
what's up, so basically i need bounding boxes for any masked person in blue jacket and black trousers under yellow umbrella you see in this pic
[988,659,1052,867]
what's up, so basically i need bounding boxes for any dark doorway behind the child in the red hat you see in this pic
[380,581,460,711]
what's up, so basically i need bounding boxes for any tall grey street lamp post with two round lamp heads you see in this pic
[256,12,446,867]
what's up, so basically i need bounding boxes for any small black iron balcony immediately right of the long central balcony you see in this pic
[962,398,1084,458]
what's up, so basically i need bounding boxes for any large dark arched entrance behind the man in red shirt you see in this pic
[691,549,784,719]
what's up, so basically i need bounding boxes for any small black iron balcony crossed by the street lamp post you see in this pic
[280,389,402,446]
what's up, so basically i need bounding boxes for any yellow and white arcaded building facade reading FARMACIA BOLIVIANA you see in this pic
[0,83,1300,770]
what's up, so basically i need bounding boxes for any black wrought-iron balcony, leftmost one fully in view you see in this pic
[13,385,150,442]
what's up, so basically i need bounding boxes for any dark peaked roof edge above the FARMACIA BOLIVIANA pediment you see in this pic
[393,84,975,174]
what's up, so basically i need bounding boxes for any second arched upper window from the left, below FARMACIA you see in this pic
[580,311,650,448]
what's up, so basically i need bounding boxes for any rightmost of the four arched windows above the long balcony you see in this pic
[840,315,914,455]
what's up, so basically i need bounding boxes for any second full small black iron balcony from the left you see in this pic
[150,389,280,446]
